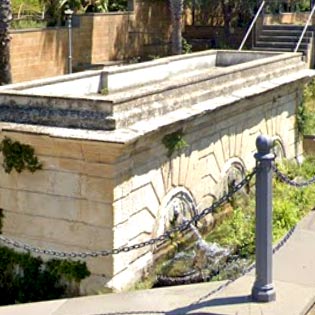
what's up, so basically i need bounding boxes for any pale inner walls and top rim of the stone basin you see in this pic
[0,50,282,98]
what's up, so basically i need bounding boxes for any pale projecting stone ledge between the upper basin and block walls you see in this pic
[0,69,315,144]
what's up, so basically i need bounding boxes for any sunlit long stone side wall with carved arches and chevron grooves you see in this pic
[109,83,302,290]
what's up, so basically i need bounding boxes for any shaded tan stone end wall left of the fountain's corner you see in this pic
[0,130,129,292]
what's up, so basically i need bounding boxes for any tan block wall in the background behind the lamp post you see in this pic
[11,1,171,82]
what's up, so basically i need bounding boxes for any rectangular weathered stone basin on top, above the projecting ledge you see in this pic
[0,50,305,130]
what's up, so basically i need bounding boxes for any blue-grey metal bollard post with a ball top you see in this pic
[252,135,276,302]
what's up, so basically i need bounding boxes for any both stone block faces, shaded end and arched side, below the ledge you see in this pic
[0,81,302,293]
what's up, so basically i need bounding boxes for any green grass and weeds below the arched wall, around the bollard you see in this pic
[134,156,315,289]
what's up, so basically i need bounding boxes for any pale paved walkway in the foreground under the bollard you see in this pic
[0,212,315,315]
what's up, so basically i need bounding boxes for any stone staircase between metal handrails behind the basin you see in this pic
[253,24,315,63]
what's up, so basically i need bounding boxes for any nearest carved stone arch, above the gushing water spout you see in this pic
[153,186,197,237]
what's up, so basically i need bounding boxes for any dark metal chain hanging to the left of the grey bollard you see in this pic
[0,168,256,258]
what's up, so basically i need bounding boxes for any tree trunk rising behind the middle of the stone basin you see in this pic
[169,0,184,55]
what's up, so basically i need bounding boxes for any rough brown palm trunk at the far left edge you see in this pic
[0,0,12,85]
